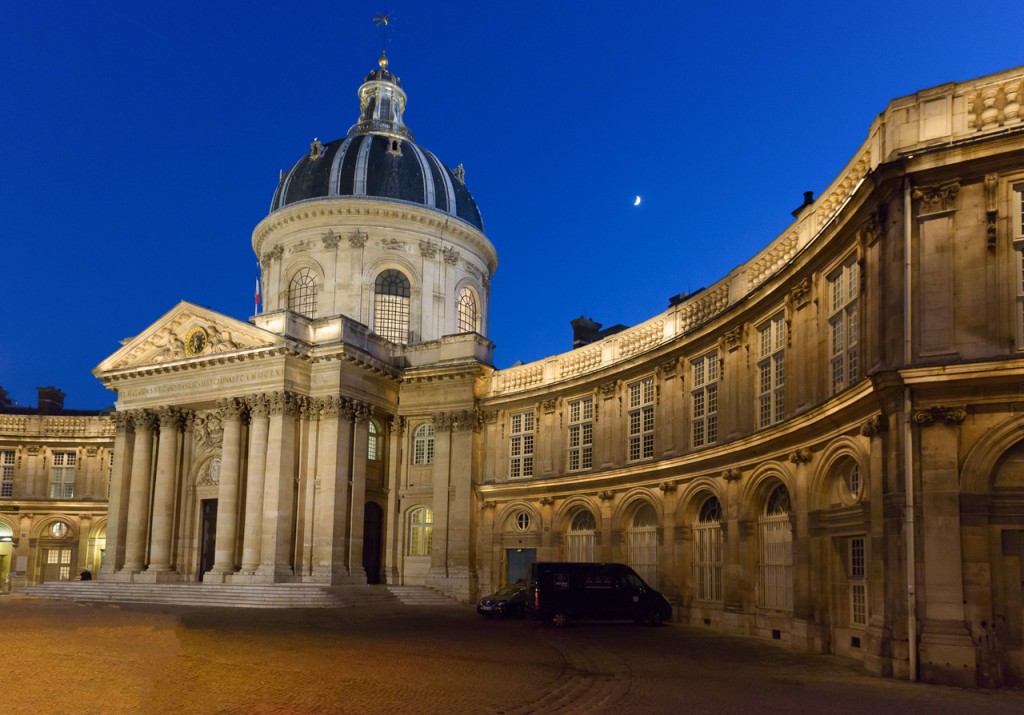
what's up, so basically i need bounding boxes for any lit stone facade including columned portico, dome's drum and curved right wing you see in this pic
[86,62,1024,684]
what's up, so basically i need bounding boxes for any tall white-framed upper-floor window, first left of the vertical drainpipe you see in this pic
[828,256,860,394]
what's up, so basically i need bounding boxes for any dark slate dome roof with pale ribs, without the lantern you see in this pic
[270,133,483,232]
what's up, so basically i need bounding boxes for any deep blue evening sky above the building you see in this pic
[0,0,1024,409]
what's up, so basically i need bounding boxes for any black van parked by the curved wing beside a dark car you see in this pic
[526,561,672,627]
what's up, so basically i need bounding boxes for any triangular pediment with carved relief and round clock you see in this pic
[93,300,284,375]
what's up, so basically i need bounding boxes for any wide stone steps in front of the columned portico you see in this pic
[22,581,397,608]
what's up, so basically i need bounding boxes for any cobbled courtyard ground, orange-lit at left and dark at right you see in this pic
[0,596,1024,715]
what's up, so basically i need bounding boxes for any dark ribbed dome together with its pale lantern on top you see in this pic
[270,56,483,233]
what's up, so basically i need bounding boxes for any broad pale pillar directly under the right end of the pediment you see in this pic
[256,392,297,582]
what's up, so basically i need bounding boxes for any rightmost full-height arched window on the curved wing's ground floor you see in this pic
[758,485,793,611]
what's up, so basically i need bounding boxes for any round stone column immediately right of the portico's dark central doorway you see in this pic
[204,397,244,581]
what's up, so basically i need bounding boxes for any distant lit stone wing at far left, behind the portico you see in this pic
[0,387,114,592]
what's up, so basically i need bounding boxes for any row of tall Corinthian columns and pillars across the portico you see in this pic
[100,391,373,584]
